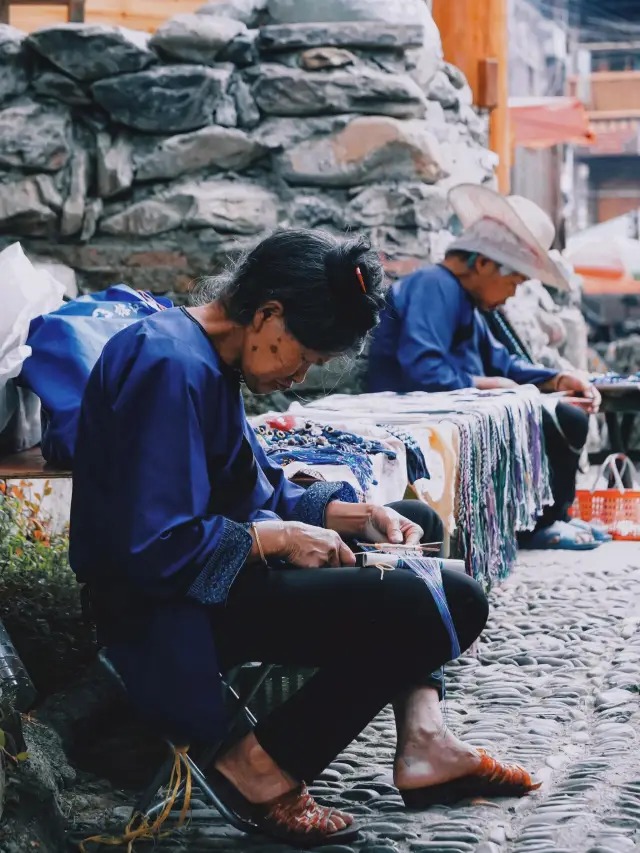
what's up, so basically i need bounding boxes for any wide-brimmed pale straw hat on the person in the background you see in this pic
[448,184,570,290]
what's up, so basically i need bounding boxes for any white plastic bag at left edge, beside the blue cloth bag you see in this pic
[0,243,64,433]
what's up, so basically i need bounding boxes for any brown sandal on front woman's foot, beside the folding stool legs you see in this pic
[207,770,360,847]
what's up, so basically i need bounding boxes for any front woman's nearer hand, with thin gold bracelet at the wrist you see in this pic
[253,521,356,569]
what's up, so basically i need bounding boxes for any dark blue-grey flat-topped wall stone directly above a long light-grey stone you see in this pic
[92,65,231,134]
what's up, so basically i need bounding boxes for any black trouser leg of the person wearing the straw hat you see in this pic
[536,403,589,530]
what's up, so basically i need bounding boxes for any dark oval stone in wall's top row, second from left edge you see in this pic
[27,24,158,82]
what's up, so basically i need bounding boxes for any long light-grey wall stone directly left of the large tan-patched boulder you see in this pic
[133,125,267,181]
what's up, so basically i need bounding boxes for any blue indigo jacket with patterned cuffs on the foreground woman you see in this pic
[70,308,356,742]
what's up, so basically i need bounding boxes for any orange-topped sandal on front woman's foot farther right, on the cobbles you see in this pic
[400,749,542,810]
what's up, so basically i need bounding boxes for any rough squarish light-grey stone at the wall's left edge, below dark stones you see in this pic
[0,100,71,172]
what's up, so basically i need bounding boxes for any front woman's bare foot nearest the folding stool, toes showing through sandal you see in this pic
[215,732,353,835]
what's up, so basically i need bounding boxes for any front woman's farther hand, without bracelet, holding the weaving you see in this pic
[325,501,424,545]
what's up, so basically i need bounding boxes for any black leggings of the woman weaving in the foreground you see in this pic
[213,501,488,782]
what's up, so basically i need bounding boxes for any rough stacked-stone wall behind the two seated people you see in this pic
[0,0,494,296]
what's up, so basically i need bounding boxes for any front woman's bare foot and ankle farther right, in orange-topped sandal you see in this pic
[393,687,482,790]
